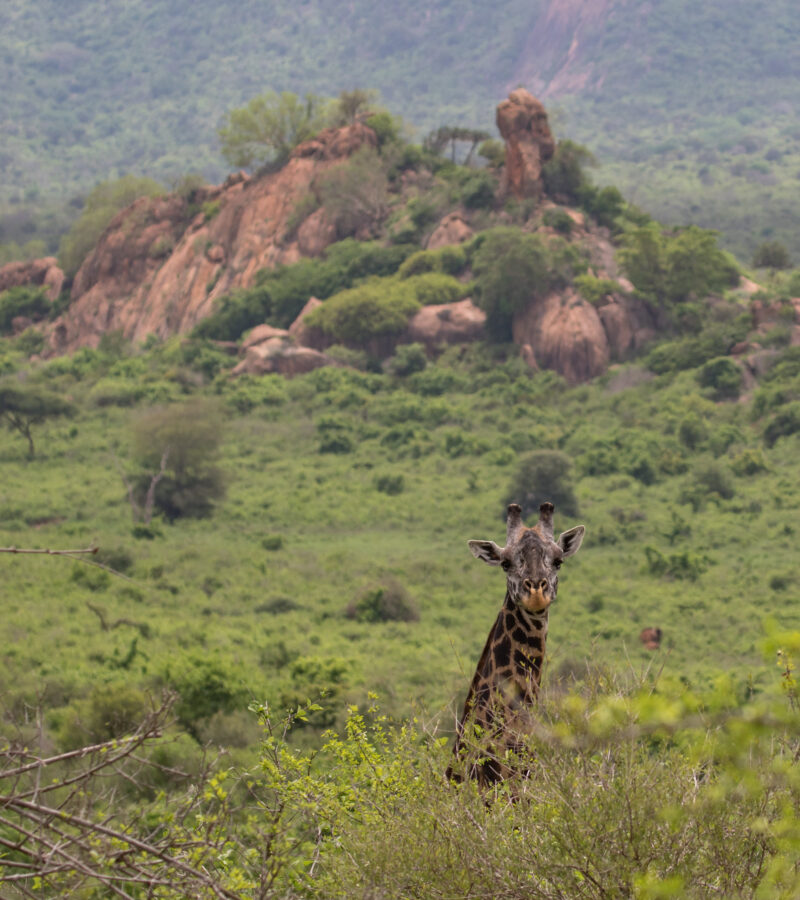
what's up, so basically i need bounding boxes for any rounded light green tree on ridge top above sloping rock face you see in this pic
[217,91,324,168]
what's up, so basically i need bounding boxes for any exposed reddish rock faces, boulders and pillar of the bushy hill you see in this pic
[26,90,656,382]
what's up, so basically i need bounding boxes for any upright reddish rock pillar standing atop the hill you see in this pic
[496,88,556,198]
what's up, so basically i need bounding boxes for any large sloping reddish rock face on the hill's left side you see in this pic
[48,123,377,355]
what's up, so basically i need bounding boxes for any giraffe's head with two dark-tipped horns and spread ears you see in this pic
[468,503,586,613]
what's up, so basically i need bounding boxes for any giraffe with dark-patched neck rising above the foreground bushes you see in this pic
[447,502,585,786]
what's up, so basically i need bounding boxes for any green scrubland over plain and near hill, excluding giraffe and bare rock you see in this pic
[0,81,800,898]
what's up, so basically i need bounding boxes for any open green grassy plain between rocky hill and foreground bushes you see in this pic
[0,334,800,748]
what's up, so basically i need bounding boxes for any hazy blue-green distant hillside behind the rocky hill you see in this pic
[0,0,800,261]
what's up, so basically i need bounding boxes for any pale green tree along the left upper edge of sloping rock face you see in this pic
[58,175,164,277]
